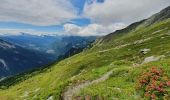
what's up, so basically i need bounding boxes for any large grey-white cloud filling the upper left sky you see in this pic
[0,0,77,26]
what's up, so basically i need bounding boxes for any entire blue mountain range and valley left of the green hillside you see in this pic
[0,33,96,78]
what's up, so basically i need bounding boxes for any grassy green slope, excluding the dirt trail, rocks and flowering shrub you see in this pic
[0,19,170,100]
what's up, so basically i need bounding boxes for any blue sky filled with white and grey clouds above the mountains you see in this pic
[0,0,170,36]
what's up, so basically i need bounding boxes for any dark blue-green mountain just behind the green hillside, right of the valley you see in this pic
[51,36,96,58]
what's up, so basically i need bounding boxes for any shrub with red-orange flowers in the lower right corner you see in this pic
[137,67,170,100]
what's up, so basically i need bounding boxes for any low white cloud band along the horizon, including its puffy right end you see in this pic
[0,23,125,36]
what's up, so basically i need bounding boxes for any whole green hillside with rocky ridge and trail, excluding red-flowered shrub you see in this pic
[0,7,170,100]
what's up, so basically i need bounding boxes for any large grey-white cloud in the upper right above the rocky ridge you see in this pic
[83,0,170,25]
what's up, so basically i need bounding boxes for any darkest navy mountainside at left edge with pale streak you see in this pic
[0,40,53,78]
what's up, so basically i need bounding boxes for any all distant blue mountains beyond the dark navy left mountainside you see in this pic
[0,33,96,57]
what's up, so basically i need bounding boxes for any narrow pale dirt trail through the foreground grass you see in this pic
[63,71,113,100]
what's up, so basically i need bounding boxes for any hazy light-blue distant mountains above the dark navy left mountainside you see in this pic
[0,33,62,53]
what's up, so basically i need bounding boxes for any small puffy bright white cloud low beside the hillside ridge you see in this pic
[64,23,126,36]
